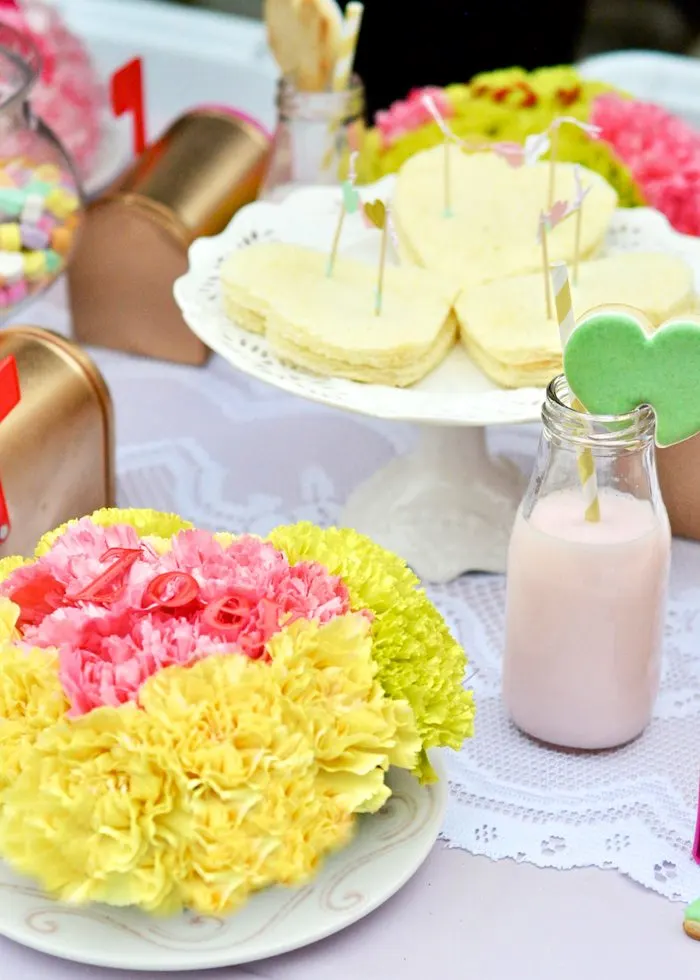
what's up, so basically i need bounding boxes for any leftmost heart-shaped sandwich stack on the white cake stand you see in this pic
[221,242,457,387]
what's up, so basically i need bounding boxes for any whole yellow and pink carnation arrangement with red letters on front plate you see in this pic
[0,510,473,914]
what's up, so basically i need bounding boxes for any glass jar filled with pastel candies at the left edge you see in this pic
[0,25,82,322]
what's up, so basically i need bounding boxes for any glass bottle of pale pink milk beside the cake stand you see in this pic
[503,376,671,749]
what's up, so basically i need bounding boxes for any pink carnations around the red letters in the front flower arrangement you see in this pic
[0,518,350,716]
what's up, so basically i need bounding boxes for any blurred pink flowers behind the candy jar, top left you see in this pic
[0,0,108,176]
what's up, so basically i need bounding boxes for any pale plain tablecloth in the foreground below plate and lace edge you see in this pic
[0,844,700,980]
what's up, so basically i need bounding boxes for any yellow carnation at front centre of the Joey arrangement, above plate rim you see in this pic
[141,655,364,912]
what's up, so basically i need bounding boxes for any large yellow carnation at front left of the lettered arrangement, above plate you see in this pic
[0,705,192,913]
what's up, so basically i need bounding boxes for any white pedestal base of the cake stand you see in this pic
[343,426,526,583]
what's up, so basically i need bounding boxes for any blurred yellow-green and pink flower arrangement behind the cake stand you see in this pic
[358,66,700,235]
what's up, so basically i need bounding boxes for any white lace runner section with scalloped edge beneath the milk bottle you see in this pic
[431,541,700,902]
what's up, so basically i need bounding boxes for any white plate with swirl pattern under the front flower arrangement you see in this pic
[0,758,447,972]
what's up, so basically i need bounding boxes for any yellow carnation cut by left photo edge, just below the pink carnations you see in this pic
[0,644,68,799]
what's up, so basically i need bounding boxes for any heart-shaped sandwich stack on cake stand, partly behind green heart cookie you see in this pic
[455,252,697,388]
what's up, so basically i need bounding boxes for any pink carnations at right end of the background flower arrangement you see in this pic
[590,94,700,235]
